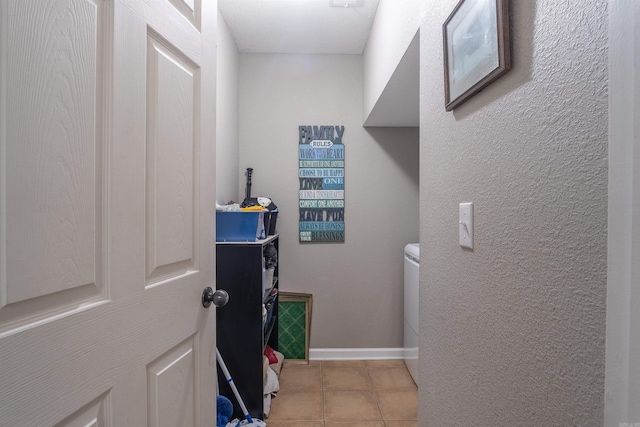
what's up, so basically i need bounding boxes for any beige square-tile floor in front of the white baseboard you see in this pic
[266,360,418,427]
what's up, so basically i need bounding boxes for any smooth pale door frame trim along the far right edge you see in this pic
[604,0,640,427]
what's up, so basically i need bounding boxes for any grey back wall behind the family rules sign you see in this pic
[240,54,419,348]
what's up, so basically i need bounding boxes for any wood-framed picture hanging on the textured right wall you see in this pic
[442,0,511,111]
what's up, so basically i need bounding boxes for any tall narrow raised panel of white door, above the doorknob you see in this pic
[146,31,200,283]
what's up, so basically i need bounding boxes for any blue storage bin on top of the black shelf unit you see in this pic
[216,211,264,242]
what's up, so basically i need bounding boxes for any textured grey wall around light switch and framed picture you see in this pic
[419,0,608,426]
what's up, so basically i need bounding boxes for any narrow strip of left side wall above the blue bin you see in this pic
[218,13,244,204]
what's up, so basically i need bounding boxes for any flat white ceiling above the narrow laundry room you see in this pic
[218,0,379,55]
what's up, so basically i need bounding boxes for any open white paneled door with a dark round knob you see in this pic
[0,0,216,427]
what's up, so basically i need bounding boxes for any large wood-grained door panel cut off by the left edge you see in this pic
[0,0,111,333]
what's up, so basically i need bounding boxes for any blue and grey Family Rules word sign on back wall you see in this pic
[298,126,344,242]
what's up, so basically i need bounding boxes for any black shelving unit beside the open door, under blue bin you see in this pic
[216,235,278,419]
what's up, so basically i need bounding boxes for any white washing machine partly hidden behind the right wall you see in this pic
[404,243,420,384]
